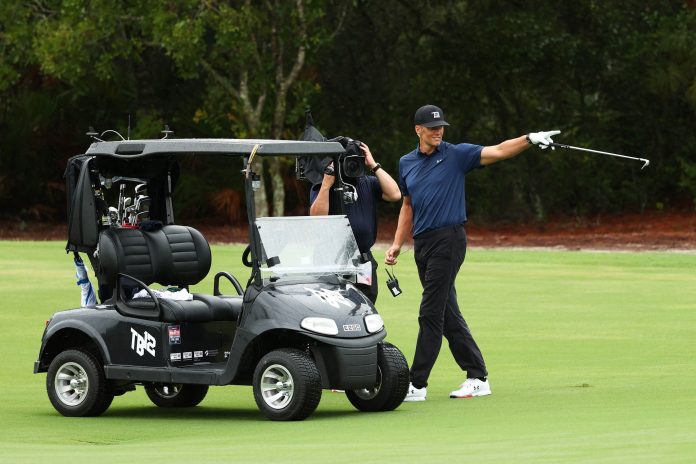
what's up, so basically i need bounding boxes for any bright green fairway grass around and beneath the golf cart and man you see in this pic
[0,241,696,464]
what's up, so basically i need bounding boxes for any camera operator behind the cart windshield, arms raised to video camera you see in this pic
[309,142,401,303]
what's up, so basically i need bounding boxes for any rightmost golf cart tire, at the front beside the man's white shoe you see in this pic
[346,343,409,412]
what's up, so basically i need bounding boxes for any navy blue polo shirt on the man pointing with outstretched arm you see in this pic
[399,141,483,237]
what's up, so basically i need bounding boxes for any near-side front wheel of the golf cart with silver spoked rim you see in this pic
[253,348,321,421]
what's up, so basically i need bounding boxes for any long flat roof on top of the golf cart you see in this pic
[85,139,345,158]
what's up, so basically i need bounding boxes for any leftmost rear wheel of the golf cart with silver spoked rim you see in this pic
[46,349,114,417]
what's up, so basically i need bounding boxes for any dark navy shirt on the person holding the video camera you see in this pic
[309,176,382,253]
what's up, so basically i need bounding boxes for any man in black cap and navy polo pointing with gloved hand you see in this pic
[385,105,560,401]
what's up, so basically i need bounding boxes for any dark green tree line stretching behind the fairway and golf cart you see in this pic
[0,0,696,222]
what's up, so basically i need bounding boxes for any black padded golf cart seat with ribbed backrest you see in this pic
[99,225,242,322]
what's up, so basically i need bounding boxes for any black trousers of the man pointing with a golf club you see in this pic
[411,225,488,387]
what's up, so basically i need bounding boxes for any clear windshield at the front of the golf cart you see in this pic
[256,216,360,276]
